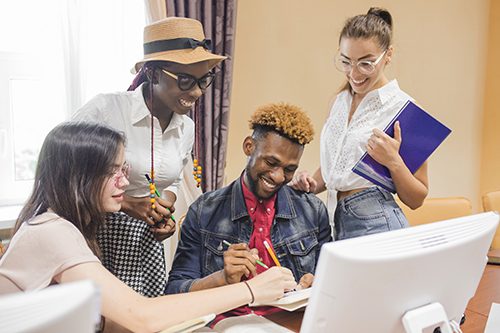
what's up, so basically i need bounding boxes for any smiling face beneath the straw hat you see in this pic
[153,61,210,115]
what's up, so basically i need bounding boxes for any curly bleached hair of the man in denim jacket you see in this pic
[249,103,314,145]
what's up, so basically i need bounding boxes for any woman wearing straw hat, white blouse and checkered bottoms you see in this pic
[74,17,226,296]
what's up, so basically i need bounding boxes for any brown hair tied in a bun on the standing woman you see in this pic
[339,7,393,91]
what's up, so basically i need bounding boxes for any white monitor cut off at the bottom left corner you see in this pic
[0,281,101,333]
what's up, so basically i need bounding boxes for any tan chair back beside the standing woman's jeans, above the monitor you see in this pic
[396,197,472,226]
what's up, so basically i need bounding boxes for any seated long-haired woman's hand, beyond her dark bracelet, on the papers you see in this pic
[247,266,297,303]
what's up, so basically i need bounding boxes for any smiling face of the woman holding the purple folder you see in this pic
[339,37,393,97]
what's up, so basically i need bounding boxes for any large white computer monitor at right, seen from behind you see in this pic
[301,212,499,333]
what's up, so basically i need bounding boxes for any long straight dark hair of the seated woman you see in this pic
[14,122,125,255]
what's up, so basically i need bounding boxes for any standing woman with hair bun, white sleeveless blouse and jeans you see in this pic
[290,8,428,239]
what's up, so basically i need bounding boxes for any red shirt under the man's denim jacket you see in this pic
[210,175,283,327]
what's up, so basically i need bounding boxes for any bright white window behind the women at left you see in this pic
[0,0,145,206]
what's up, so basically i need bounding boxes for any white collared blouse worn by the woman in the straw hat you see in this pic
[73,85,194,197]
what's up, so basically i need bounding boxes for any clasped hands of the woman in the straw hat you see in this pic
[122,195,175,241]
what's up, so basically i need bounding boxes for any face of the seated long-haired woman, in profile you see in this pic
[101,145,129,213]
